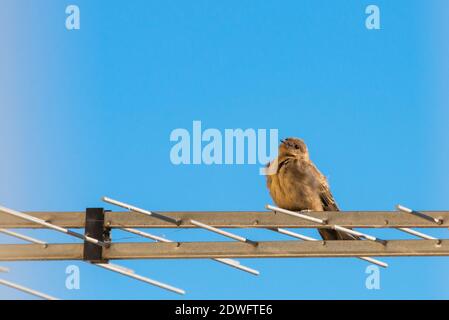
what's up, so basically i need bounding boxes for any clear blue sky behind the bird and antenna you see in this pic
[0,0,449,299]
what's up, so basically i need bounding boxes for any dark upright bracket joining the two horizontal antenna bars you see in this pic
[83,208,111,263]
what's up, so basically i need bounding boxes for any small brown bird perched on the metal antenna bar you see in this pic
[267,138,357,240]
